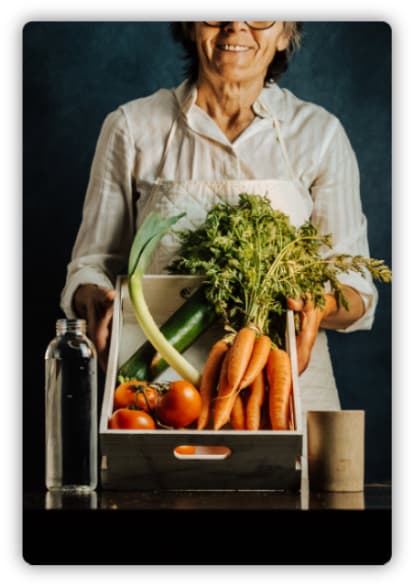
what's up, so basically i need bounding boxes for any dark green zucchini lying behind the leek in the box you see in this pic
[118,287,218,382]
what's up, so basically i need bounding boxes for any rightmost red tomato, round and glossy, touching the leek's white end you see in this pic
[155,380,202,428]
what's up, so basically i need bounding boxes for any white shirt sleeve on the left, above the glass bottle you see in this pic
[61,109,134,318]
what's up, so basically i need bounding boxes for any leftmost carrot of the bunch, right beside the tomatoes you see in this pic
[197,340,229,429]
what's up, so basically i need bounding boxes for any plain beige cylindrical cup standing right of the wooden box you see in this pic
[307,410,365,492]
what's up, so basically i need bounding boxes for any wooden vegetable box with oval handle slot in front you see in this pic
[99,275,302,491]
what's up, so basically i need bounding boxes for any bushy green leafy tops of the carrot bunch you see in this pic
[169,194,391,343]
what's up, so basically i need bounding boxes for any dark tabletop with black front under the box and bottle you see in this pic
[23,483,392,565]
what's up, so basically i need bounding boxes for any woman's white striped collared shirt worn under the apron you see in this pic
[61,82,377,332]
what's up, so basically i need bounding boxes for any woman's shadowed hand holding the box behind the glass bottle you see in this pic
[74,284,116,371]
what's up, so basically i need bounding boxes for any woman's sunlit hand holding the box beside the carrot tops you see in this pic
[287,287,365,374]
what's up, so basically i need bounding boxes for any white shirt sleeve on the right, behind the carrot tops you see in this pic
[311,119,378,333]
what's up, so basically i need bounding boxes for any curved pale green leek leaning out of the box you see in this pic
[128,212,200,386]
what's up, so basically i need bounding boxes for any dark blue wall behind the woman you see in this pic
[23,22,391,488]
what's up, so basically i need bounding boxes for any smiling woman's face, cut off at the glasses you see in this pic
[193,22,289,83]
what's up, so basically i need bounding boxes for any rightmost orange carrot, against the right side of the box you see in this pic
[266,348,292,430]
